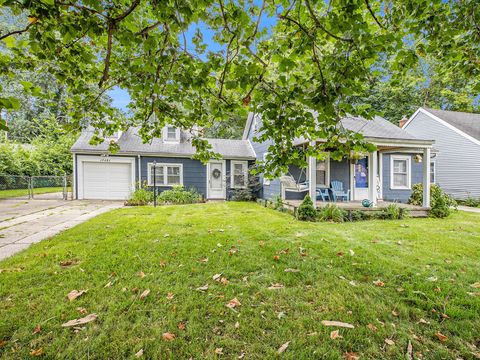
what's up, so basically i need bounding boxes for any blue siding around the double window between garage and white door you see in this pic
[141,156,206,197]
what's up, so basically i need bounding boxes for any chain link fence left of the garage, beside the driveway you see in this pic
[0,175,72,200]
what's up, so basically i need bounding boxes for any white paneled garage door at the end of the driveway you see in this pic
[83,161,132,200]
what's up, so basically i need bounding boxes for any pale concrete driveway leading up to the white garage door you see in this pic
[0,199,123,260]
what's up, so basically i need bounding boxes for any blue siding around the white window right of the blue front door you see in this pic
[382,153,423,203]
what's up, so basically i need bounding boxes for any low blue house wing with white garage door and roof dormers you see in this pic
[72,126,255,200]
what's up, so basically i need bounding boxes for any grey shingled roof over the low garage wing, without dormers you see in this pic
[71,127,255,159]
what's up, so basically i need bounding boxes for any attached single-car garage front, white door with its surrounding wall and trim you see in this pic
[77,156,135,200]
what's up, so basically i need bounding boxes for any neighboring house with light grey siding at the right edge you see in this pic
[403,108,480,199]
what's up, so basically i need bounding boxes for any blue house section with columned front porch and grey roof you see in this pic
[243,114,434,207]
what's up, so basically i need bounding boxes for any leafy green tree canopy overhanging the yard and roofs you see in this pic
[0,0,480,175]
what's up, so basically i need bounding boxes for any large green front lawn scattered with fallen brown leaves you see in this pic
[0,203,480,359]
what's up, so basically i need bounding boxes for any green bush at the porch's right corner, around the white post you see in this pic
[408,184,457,218]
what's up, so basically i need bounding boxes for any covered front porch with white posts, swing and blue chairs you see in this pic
[281,139,432,211]
